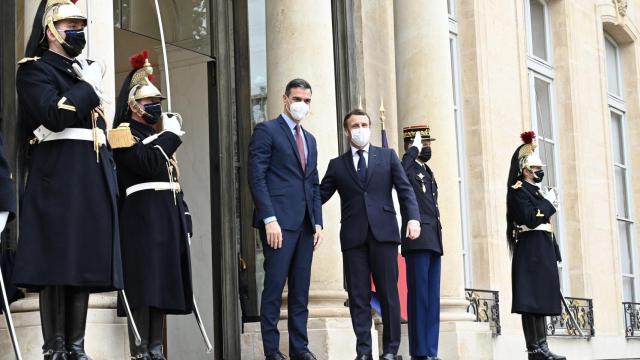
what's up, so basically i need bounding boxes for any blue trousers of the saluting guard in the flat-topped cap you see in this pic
[405,250,441,357]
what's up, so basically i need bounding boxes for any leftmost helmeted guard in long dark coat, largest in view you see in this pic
[13,0,123,360]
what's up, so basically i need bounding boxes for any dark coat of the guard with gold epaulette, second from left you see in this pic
[113,120,193,315]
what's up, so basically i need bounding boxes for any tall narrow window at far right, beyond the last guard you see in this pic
[604,35,638,301]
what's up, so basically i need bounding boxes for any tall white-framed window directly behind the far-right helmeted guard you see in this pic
[525,0,568,289]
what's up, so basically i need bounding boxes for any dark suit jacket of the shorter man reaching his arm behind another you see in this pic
[320,145,420,251]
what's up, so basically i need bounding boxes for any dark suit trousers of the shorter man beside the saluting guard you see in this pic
[342,231,400,355]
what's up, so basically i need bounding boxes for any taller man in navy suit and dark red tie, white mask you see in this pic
[249,79,322,360]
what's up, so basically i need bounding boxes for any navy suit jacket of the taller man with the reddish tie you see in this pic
[248,116,322,230]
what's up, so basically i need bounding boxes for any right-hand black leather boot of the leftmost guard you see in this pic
[65,286,91,360]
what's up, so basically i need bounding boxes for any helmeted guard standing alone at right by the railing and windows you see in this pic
[507,131,565,360]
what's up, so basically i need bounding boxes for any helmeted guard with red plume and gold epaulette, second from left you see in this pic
[109,51,193,360]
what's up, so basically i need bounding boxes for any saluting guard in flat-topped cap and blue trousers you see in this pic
[402,125,442,360]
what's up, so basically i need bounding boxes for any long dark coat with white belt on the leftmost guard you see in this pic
[14,51,123,291]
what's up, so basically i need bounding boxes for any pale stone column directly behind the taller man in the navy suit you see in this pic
[244,0,364,359]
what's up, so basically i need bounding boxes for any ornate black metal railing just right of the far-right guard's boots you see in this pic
[546,297,595,338]
